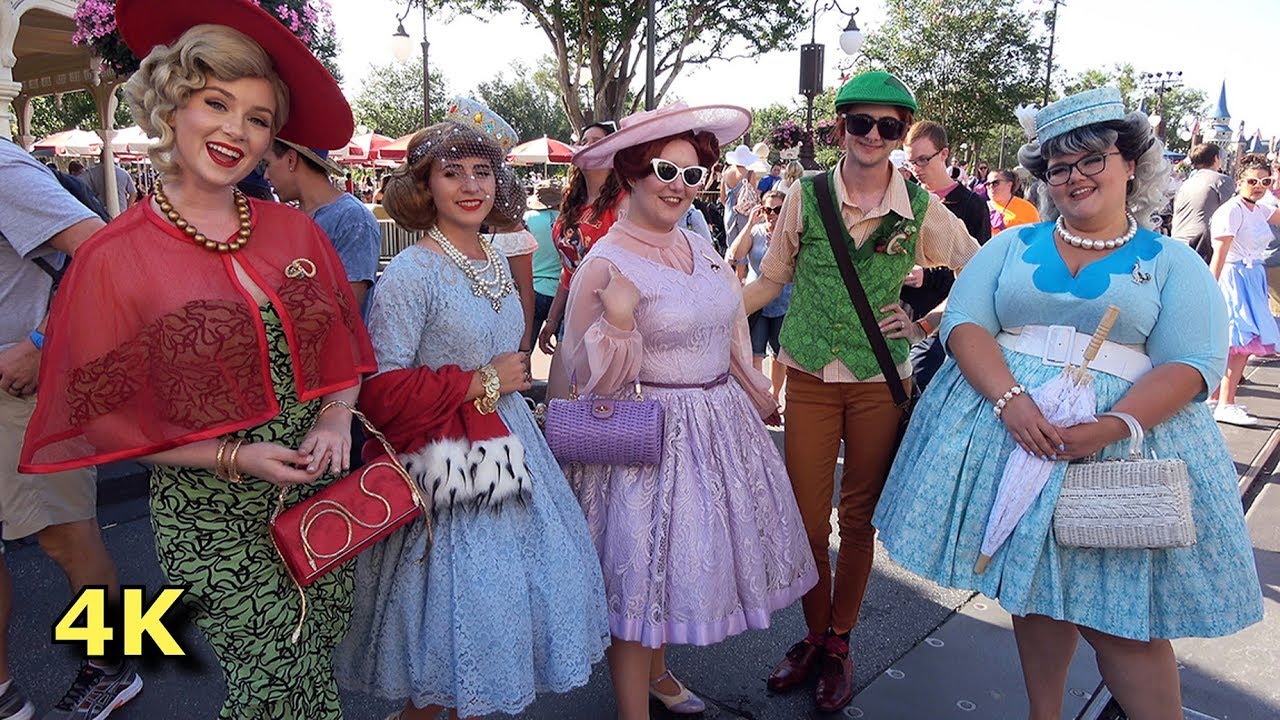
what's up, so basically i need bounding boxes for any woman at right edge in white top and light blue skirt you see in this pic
[1208,149,1280,427]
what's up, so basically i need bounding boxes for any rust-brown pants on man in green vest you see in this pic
[783,368,910,633]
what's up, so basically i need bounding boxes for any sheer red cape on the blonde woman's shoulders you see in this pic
[19,199,376,473]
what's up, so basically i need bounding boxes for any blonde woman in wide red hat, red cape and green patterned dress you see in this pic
[22,0,375,720]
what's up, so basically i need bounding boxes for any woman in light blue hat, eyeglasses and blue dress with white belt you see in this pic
[874,88,1262,720]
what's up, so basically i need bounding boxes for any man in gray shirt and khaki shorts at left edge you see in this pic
[0,138,142,717]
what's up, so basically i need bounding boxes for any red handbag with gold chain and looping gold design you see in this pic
[271,401,431,641]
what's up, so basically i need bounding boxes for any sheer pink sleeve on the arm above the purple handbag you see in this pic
[561,256,645,395]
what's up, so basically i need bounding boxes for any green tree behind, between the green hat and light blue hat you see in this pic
[863,0,1044,159]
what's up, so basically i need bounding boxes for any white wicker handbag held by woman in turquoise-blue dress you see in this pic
[1053,413,1196,548]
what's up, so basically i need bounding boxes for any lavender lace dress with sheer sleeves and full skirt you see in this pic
[564,220,817,647]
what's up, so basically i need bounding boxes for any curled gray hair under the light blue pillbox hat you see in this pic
[1018,113,1169,229]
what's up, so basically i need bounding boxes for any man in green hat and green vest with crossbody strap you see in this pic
[745,72,978,712]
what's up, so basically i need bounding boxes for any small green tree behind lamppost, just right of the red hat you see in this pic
[351,60,451,137]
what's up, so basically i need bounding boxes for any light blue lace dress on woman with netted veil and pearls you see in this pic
[335,246,609,716]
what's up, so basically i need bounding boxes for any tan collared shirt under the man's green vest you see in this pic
[760,159,978,383]
